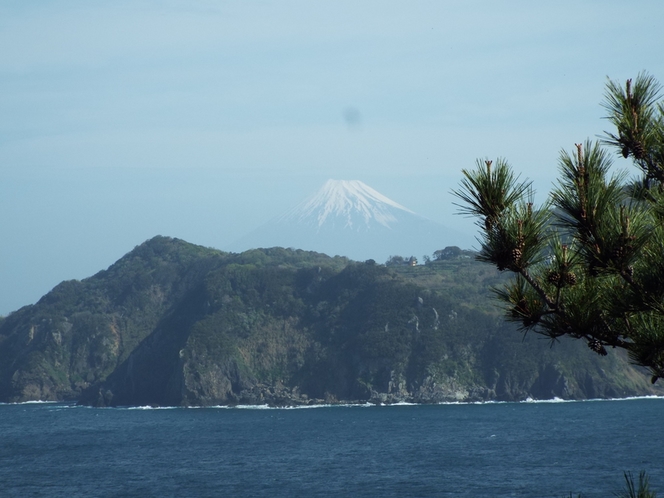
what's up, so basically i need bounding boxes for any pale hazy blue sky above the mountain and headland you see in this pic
[0,0,664,314]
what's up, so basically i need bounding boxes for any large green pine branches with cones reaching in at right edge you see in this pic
[453,73,664,383]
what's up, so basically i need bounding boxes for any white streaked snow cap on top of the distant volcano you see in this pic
[279,180,414,228]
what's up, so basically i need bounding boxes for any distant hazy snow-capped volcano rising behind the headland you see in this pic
[227,180,474,263]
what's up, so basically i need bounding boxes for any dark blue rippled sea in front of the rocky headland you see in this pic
[0,399,664,498]
